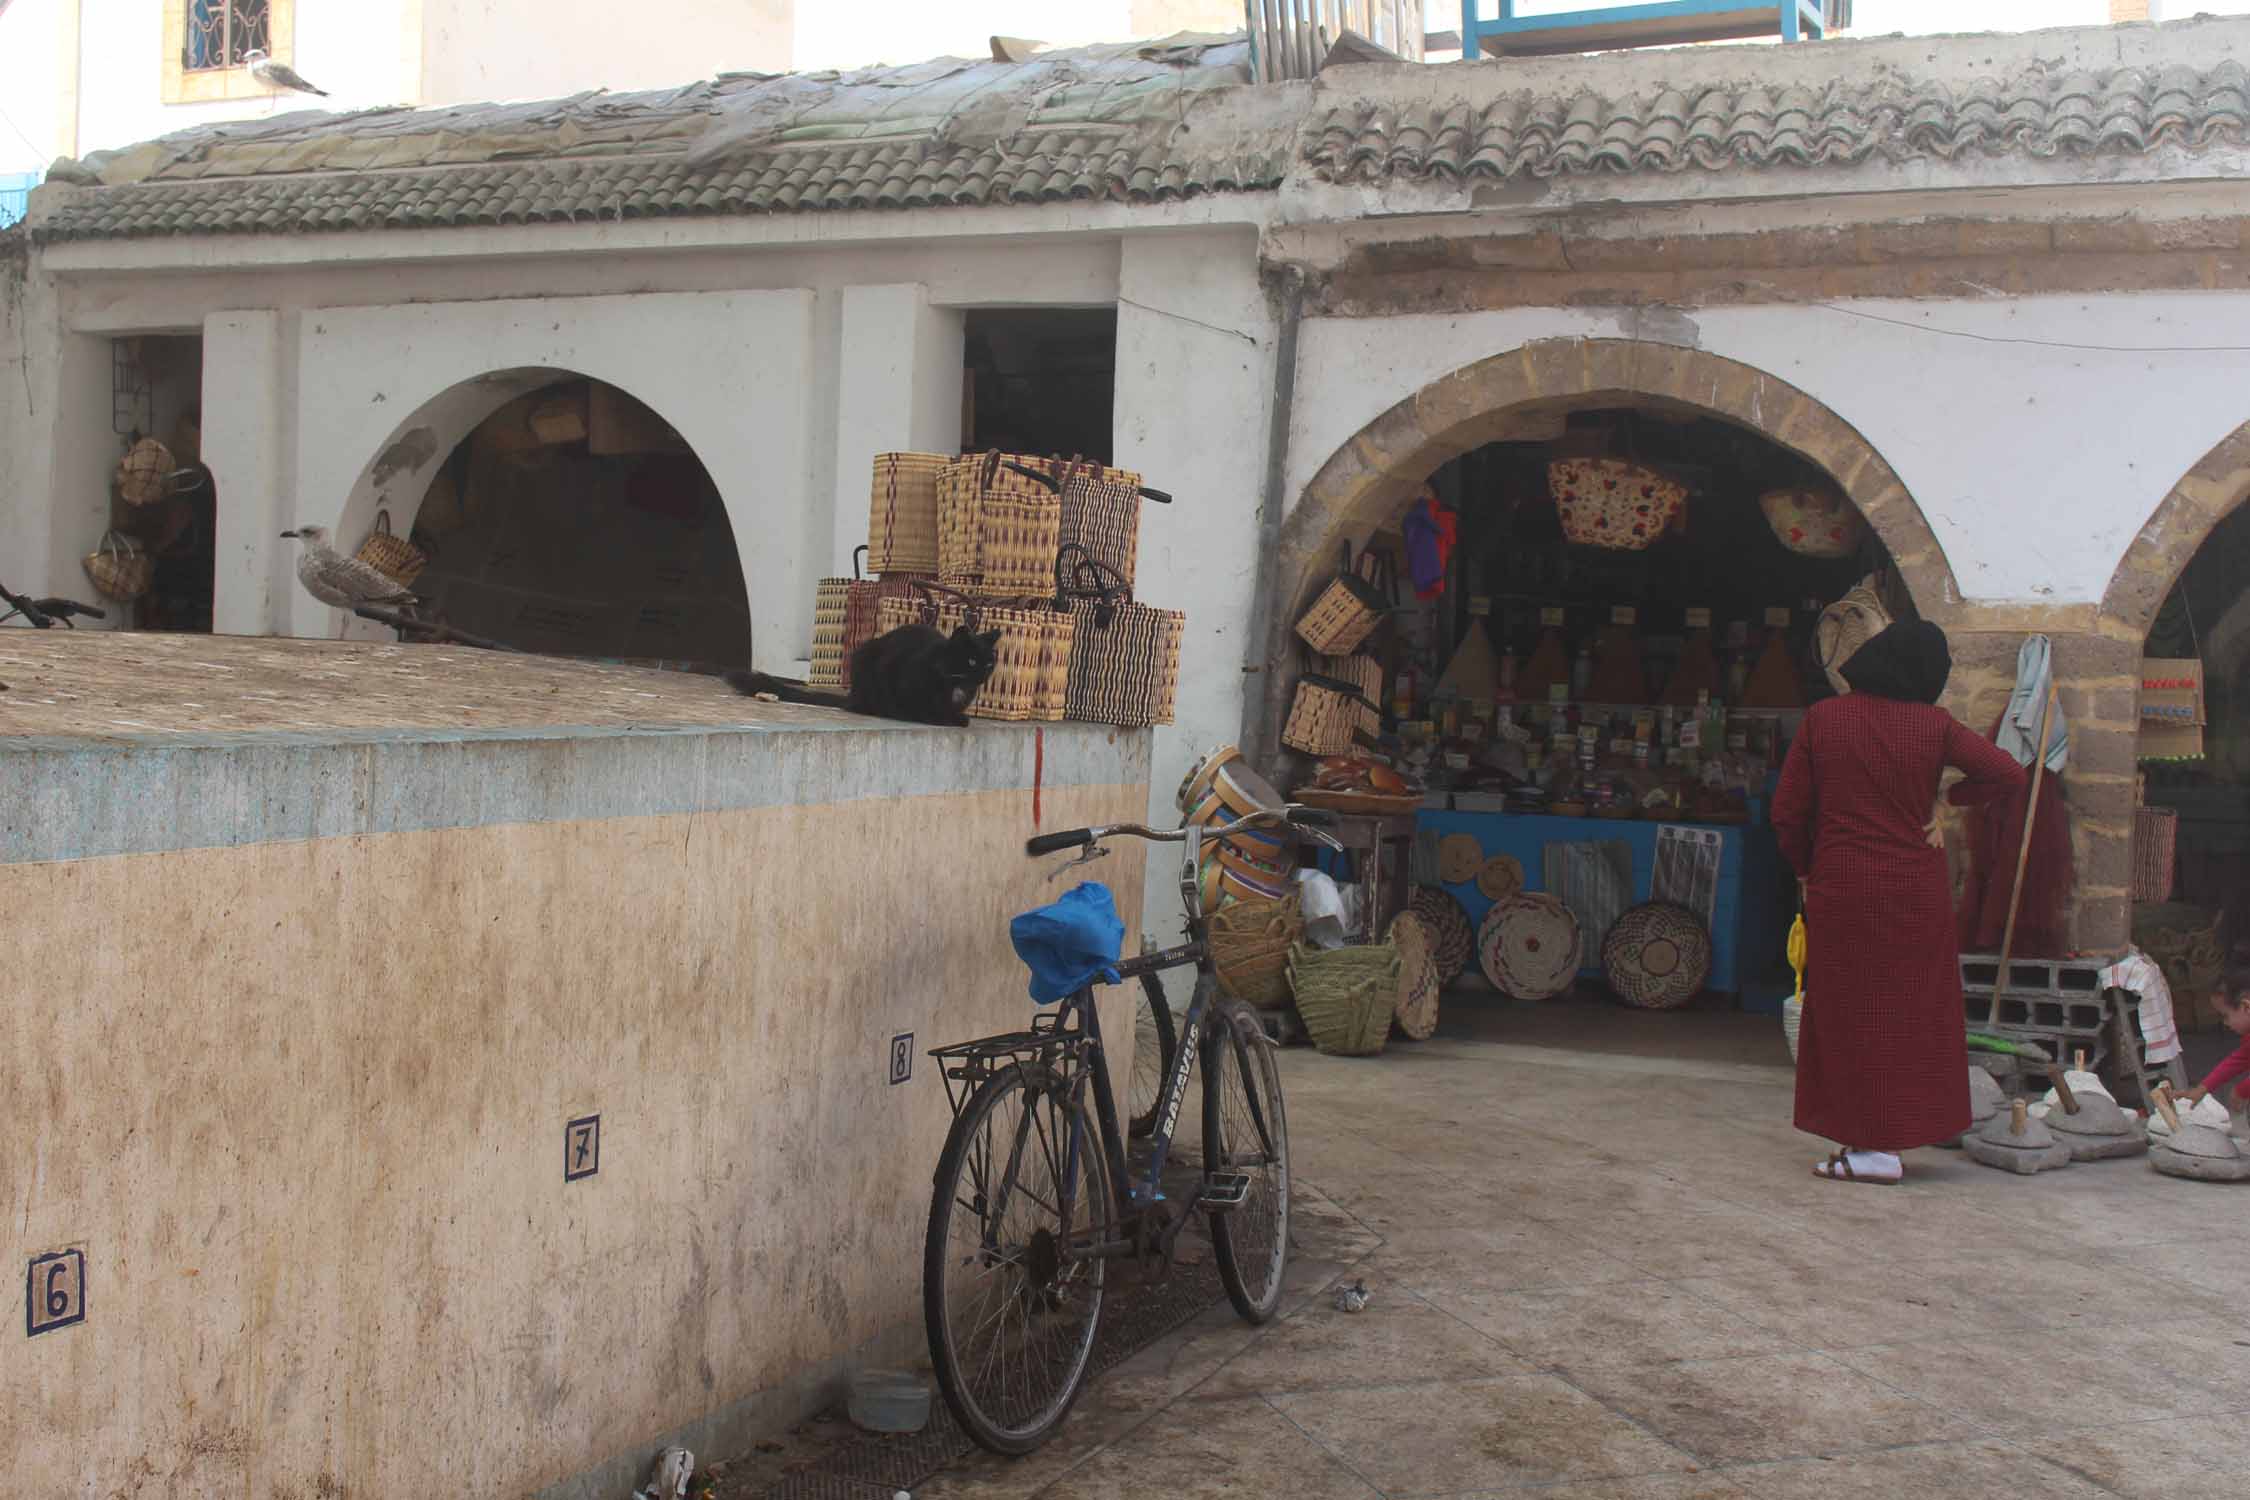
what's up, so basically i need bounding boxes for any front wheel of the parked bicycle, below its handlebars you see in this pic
[1204,999,1289,1322]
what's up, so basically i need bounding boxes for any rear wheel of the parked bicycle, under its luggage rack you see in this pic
[923,1064,1114,1453]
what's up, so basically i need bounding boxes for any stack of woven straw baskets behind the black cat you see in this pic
[810,452,1188,726]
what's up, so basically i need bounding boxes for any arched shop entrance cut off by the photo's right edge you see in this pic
[2102,423,2250,1075]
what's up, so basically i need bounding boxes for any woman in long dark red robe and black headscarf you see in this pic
[1773,621,2025,1183]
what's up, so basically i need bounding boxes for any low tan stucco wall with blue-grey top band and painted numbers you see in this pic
[0,715,1148,1496]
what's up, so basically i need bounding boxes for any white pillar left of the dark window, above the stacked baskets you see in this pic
[830,286,963,576]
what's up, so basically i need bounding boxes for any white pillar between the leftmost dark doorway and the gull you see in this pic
[203,313,297,636]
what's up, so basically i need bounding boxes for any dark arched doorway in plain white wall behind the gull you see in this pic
[321,369,752,666]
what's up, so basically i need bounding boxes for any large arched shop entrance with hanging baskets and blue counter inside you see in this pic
[1262,340,1958,1050]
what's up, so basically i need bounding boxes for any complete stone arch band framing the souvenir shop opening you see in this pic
[1251,337,1962,751]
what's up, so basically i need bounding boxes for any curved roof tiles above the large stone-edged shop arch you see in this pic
[1305,58,2250,182]
